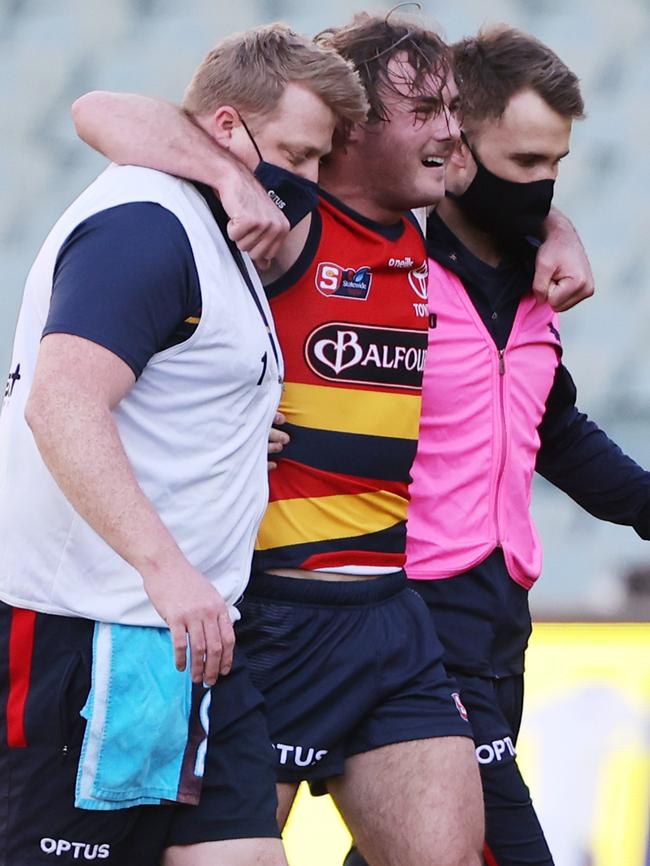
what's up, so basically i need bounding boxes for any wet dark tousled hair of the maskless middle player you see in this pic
[316,12,452,123]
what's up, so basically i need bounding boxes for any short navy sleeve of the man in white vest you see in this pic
[43,202,201,378]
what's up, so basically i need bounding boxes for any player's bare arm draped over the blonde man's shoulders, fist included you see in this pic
[72,91,289,268]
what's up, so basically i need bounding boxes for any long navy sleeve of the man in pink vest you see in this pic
[537,364,650,540]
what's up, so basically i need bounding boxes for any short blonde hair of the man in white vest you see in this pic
[183,24,368,123]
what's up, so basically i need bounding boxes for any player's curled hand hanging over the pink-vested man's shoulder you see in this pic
[533,208,595,313]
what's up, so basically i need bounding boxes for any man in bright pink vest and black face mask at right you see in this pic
[346,28,650,866]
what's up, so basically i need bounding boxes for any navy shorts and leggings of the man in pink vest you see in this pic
[404,568,553,866]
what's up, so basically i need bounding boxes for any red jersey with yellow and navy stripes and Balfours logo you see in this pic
[255,187,429,574]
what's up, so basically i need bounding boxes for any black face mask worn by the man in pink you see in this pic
[447,136,555,240]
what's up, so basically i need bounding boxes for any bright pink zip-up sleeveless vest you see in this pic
[406,253,562,589]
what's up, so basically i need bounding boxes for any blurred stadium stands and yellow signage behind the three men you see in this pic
[0,0,650,866]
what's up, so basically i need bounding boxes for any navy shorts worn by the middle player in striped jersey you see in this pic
[236,572,471,793]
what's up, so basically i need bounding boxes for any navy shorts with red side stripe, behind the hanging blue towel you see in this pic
[0,602,280,866]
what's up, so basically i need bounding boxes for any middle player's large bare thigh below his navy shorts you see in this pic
[328,737,484,866]
